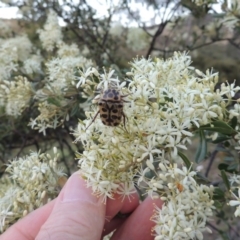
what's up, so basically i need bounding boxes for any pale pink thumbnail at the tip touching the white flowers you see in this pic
[63,172,101,203]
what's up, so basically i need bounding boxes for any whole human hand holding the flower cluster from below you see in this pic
[0,173,162,240]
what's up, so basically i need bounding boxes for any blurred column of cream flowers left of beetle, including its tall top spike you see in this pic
[25,11,94,135]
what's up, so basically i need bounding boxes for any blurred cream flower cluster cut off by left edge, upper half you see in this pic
[0,36,39,117]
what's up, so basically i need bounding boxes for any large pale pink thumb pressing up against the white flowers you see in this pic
[35,172,106,240]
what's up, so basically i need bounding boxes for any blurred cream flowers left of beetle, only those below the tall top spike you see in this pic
[29,56,93,134]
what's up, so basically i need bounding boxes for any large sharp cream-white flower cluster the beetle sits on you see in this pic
[74,52,239,239]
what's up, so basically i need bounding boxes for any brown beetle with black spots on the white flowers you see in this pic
[86,88,128,130]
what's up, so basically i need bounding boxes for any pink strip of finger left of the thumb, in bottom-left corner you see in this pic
[0,199,56,240]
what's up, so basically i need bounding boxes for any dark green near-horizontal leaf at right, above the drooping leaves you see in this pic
[199,121,236,135]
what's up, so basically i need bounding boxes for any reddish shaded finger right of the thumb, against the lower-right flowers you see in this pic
[111,198,163,240]
